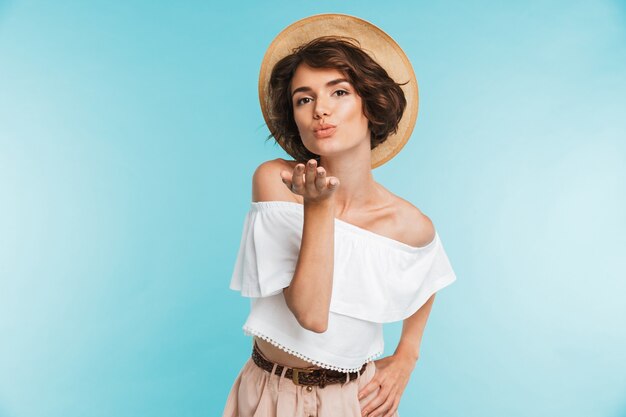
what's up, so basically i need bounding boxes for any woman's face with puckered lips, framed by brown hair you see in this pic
[290,64,370,155]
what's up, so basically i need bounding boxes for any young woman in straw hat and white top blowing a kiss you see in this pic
[224,14,456,417]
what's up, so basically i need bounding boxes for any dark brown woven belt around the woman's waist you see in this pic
[252,341,367,388]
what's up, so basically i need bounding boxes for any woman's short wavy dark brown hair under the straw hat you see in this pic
[267,36,408,162]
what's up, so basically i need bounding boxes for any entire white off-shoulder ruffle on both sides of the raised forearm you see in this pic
[230,201,456,323]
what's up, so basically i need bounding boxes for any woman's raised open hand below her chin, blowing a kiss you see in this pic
[280,159,339,203]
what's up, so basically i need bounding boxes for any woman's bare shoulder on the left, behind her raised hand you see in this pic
[252,158,297,202]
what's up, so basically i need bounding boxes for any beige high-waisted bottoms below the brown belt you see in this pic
[223,350,399,417]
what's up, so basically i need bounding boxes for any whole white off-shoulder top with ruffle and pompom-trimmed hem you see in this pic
[230,201,456,372]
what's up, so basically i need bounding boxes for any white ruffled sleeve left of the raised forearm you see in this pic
[230,202,302,297]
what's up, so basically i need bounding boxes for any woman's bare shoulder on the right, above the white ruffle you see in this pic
[382,190,435,247]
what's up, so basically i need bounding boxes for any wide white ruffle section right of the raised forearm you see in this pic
[330,224,456,323]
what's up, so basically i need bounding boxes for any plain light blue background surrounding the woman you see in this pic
[0,0,626,417]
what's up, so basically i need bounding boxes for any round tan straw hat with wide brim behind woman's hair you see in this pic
[259,13,419,168]
